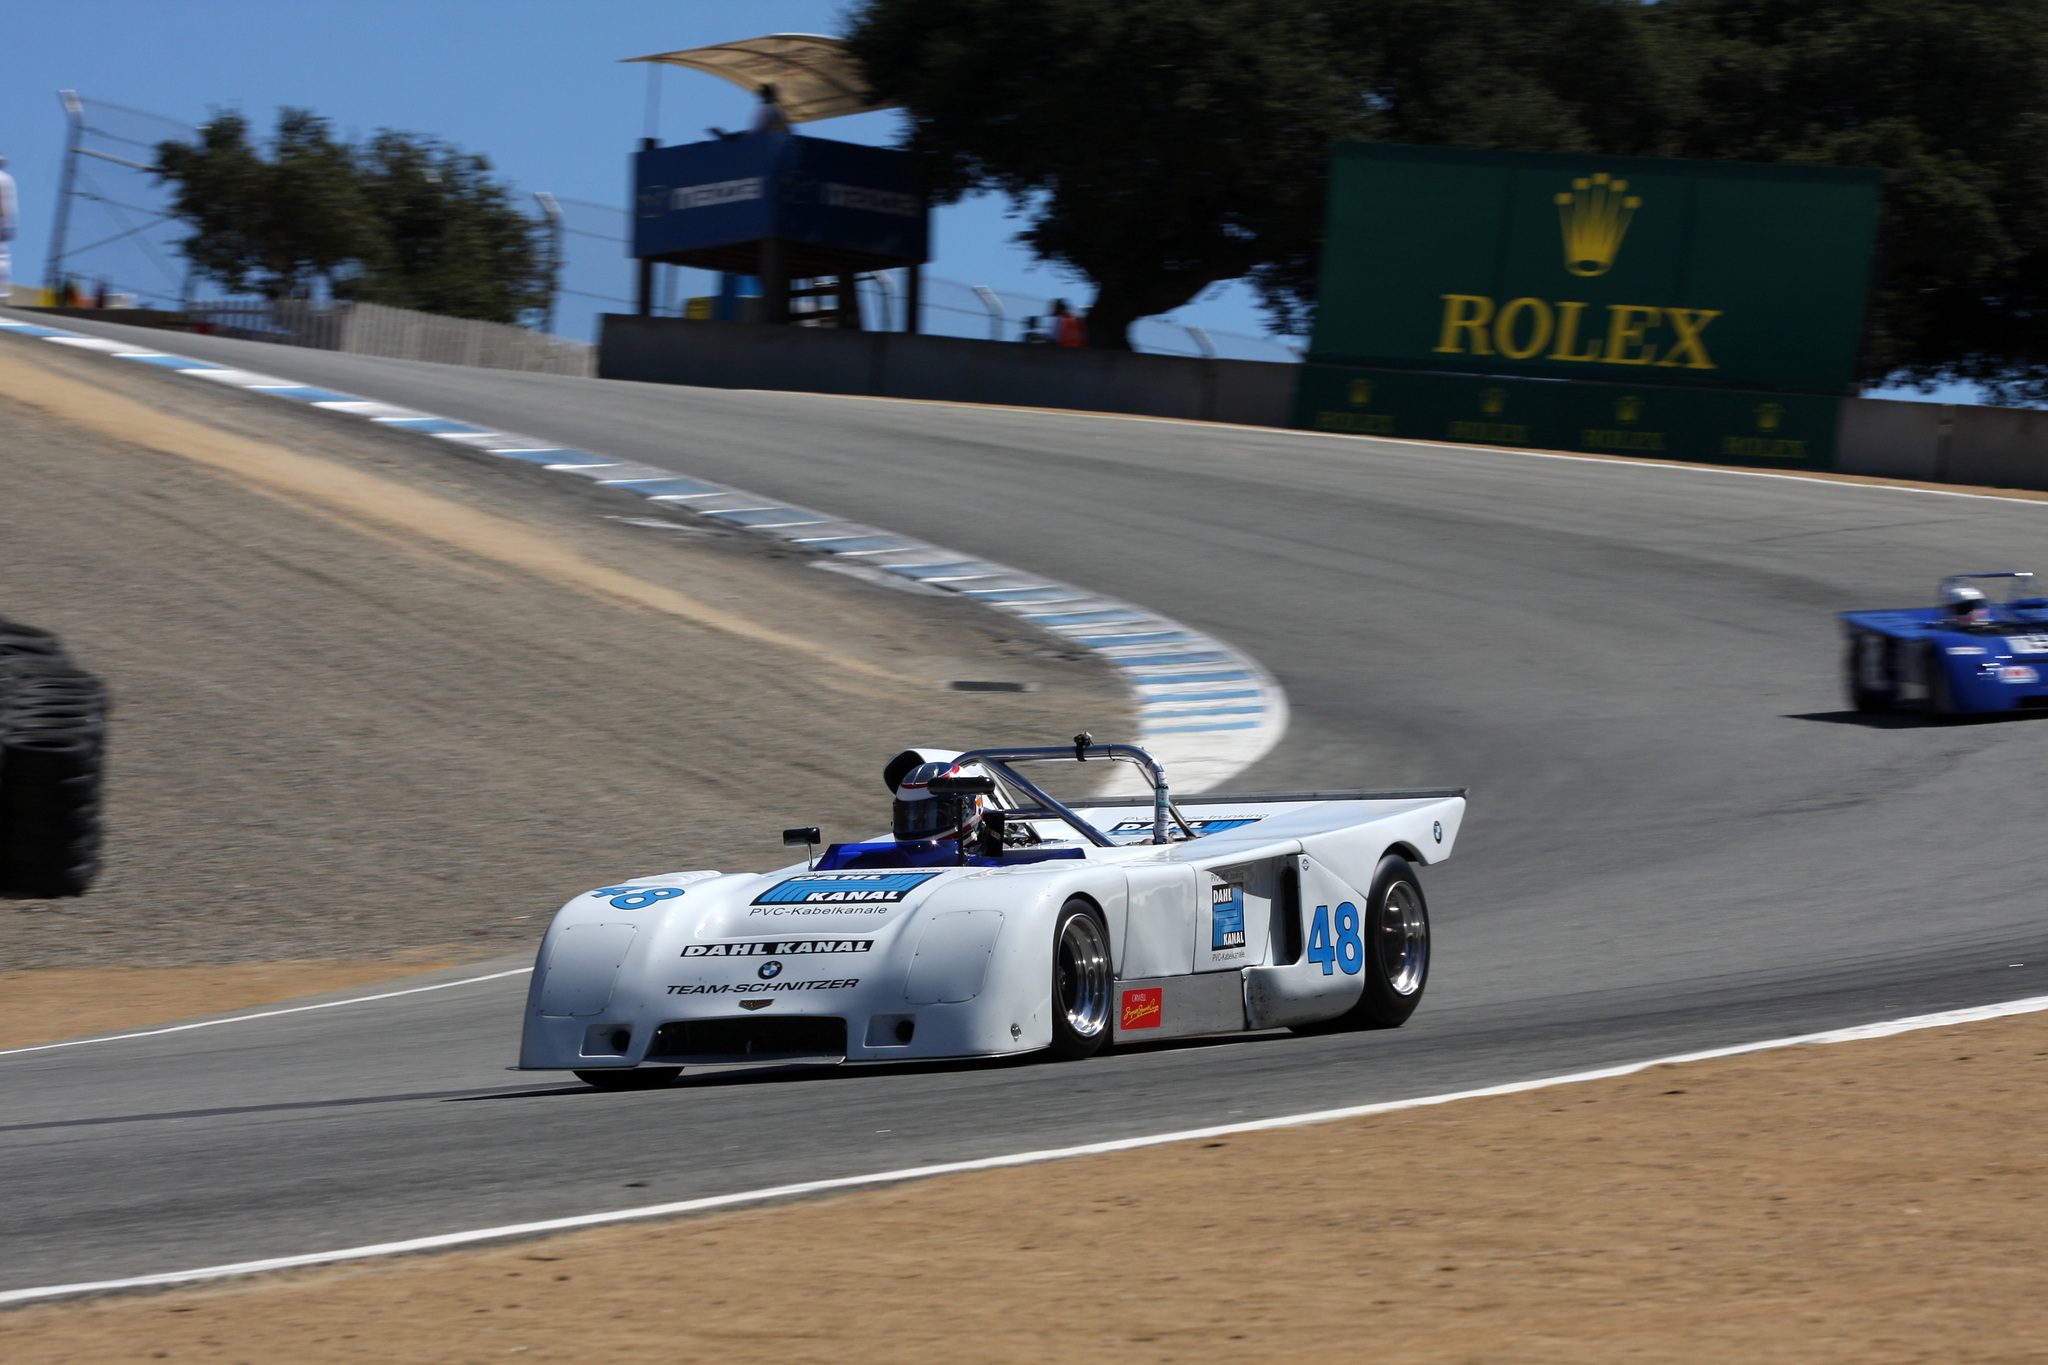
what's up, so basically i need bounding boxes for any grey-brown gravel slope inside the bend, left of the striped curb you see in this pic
[0,338,1137,978]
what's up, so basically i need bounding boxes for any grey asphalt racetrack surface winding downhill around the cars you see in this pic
[0,321,2048,1289]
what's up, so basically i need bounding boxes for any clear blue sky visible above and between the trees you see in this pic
[0,0,1970,401]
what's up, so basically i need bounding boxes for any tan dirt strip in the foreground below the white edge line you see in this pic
[0,998,2048,1365]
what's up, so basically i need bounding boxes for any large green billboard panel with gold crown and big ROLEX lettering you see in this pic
[1309,143,1884,394]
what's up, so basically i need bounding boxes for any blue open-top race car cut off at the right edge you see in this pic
[1841,573,2048,720]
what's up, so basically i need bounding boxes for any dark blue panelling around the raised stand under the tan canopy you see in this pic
[633,133,930,266]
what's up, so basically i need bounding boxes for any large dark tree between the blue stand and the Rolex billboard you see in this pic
[848,0,1368,348]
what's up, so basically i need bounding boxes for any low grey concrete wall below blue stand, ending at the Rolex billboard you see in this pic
[598,313,1298,426]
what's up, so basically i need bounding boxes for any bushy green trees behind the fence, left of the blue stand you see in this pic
[156,108,553,323]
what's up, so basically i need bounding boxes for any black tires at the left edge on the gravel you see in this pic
[0,616,106,900]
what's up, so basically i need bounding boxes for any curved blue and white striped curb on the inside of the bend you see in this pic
[0,317,1288,792]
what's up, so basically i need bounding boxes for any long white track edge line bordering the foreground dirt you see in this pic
[0,995,2048,1306]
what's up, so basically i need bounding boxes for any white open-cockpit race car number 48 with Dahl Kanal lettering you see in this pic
[520,735,1464,1089]
